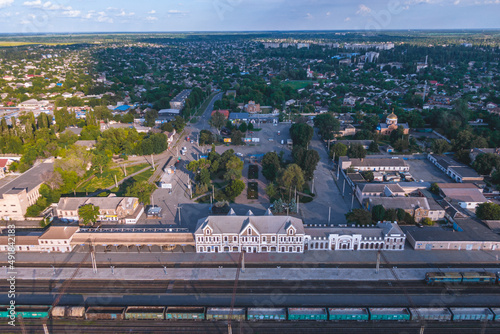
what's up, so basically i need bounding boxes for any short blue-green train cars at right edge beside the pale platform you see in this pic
[425,271,500,285]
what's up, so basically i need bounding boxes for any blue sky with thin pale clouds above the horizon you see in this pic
[0,0,500,33]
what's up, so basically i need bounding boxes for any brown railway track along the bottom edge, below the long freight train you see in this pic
[5,319,500,334]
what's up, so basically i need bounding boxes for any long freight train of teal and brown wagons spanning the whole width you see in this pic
[0,306,500,322]
